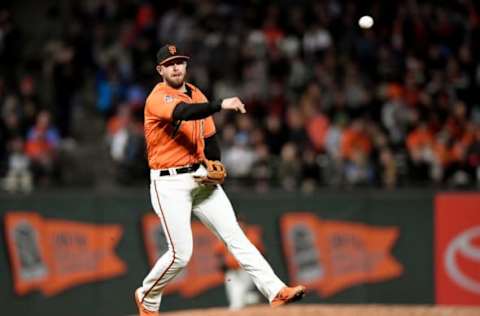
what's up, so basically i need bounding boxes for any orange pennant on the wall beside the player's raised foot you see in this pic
[281,213,403,297]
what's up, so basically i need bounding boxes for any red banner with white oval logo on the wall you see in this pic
[435,194,480,305]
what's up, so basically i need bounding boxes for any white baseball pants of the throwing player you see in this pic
[137,166,285,311]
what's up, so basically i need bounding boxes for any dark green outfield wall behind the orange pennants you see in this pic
[0,189,434,316]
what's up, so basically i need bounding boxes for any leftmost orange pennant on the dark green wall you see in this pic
[5,212,126,296]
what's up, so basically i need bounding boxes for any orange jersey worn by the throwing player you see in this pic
[144,82,215,169]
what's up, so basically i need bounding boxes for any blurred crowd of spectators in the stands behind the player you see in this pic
[0,0,480,192]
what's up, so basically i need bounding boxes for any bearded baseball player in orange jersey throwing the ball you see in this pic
[135,45,305,316]
